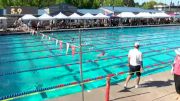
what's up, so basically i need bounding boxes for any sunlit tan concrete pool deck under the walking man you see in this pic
[49,71,176,101]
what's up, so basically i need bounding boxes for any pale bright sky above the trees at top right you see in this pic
[134,0,180,5]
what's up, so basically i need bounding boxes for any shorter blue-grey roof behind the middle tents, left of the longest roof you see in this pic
[77,9,104,15]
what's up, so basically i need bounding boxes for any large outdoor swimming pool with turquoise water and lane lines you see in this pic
[0,26,180,101]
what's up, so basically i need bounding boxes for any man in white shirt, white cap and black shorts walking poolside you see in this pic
[124,42,143,88]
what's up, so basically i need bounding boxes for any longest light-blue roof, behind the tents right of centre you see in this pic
[102,6,160,13]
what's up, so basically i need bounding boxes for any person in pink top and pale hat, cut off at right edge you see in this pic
[171,48,180,101]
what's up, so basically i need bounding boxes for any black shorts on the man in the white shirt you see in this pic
[129,65,141,77]
